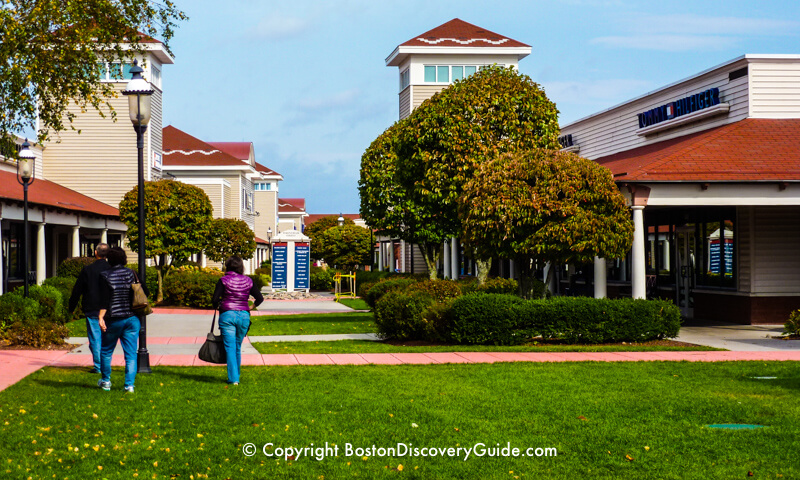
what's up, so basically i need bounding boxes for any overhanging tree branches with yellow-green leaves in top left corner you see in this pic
[0,0,186,152]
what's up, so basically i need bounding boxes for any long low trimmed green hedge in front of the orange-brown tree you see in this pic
[443,294,681,345]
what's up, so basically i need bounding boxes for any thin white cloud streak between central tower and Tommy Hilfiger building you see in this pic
[590,34,737,52]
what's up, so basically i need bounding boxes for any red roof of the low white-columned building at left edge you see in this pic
[0,171,119,217]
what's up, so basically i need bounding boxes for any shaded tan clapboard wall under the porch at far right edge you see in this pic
[752,207,800,294]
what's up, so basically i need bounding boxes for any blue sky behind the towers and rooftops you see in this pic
[164,0,800,213]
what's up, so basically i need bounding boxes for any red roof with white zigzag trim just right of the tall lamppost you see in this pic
[162,125,249,167]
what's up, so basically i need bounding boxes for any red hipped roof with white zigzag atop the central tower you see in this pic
[400,18,530,47]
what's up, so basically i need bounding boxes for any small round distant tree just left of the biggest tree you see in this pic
[312,225,372,268]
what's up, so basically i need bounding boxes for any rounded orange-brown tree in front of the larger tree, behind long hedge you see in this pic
[460,149,633,297]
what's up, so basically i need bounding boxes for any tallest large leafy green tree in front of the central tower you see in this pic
[359,66,558,278]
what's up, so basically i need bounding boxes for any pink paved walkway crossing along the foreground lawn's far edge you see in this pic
[0,348,800,390]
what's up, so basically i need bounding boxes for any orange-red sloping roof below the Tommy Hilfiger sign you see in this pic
[595,118,800,182]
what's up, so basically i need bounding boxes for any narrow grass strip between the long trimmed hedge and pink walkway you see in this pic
[253,340,721,353]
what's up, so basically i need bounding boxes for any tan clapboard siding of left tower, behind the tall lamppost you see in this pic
[44,83,148,207]
